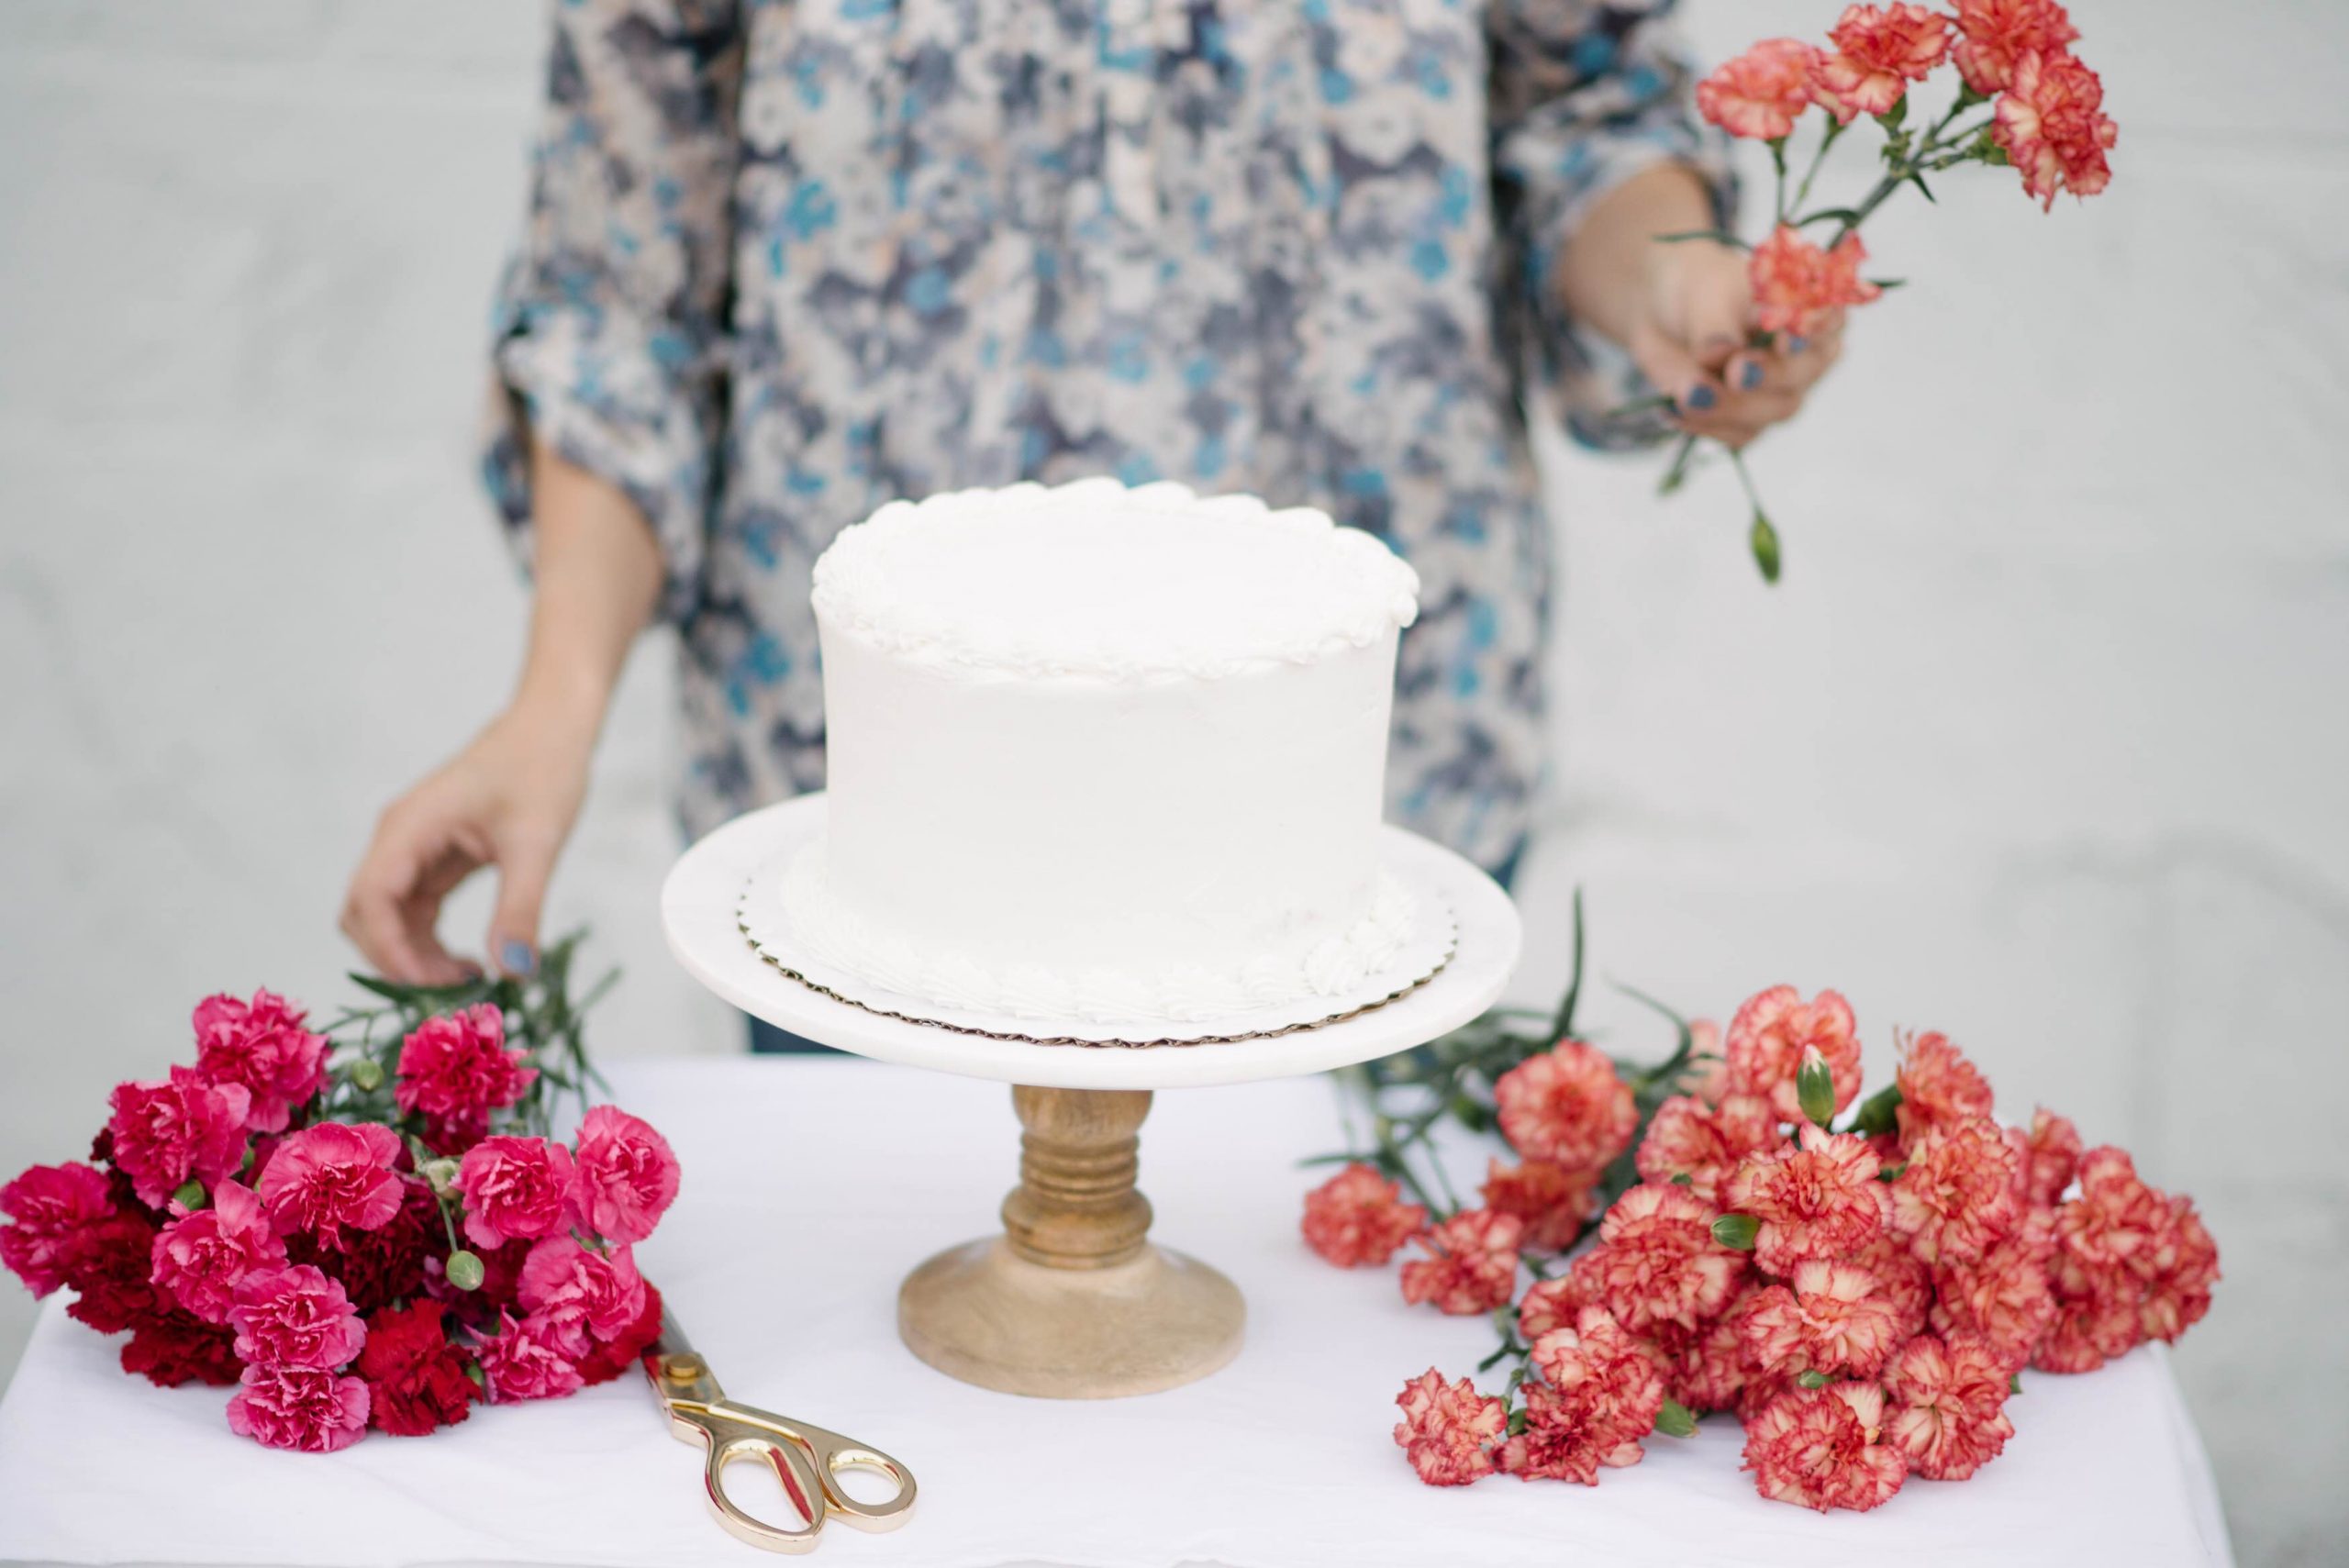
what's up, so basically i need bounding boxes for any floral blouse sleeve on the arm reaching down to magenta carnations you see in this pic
[484,0,740,619]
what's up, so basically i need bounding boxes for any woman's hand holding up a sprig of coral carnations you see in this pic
[1623,239,1844,446]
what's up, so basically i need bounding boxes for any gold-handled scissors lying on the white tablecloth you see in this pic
[643,1307,914,1551]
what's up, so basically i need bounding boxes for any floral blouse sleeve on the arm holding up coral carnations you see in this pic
[1489,0,1736,449]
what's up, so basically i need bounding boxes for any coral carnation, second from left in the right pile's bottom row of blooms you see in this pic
[1497,1307,1663,1485]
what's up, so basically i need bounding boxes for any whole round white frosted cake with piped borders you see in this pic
[780,479,1419,1021]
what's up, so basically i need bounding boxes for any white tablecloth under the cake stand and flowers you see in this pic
[0,1047,2229,1568]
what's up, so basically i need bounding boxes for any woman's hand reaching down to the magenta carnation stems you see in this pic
[340,702,599,986]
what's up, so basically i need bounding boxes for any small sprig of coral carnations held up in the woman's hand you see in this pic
[1663,0,2117,582]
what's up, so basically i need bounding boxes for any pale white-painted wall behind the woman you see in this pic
[0,0,2349,1563]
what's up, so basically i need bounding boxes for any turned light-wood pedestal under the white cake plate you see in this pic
[897,1084,1247,1399]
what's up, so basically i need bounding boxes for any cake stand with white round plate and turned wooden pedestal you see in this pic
[660,795,1520,1399]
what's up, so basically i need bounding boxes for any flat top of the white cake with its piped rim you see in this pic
[815,479,1419,681]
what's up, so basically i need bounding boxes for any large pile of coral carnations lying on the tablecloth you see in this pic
[1304,906,2218,1509]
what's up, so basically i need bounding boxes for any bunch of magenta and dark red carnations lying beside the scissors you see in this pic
[0,939,679,1453]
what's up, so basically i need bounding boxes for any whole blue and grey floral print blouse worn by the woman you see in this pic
[486,0,1721,863]
